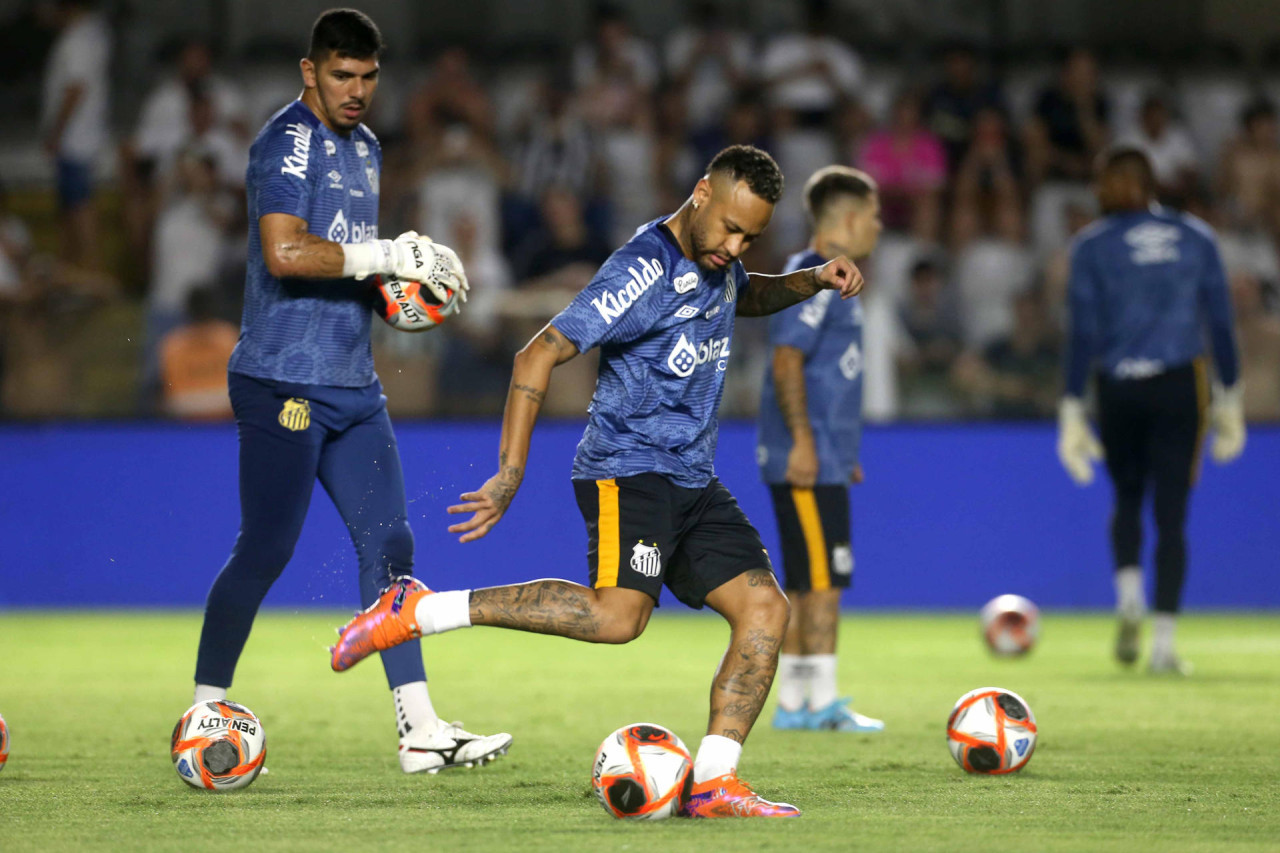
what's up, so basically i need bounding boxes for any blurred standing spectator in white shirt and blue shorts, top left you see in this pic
[40,0,111,269]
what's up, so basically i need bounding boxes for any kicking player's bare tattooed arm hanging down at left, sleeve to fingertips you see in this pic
[448,323,577,542]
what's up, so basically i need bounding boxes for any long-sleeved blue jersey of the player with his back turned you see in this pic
[1066,205,1239,397]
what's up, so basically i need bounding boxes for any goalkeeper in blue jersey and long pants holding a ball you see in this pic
[196,9,511,772]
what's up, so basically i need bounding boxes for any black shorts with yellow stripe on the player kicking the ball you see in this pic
[573,474,773,610]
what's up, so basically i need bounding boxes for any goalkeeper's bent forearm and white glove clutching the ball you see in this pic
[257,213,468,301]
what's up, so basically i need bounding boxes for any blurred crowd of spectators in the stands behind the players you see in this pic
[0,0,1280,420]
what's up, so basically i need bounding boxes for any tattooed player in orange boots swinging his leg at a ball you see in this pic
[332,146,863,817]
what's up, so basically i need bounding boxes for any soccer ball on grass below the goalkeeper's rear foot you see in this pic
[169,701,266,790]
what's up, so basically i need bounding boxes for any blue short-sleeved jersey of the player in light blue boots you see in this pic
[755,251,863,485]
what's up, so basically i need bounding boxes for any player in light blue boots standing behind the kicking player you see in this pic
[756,165,884,731]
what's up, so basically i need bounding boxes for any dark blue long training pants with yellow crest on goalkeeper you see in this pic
[196,373,426,688]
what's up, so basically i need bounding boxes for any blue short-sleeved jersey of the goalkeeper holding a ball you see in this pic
[229,101,383,388]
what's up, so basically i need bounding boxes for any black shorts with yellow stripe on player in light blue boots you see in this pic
[769,484,854,592]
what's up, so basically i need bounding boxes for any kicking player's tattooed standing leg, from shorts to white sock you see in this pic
[707,569,787,743]
